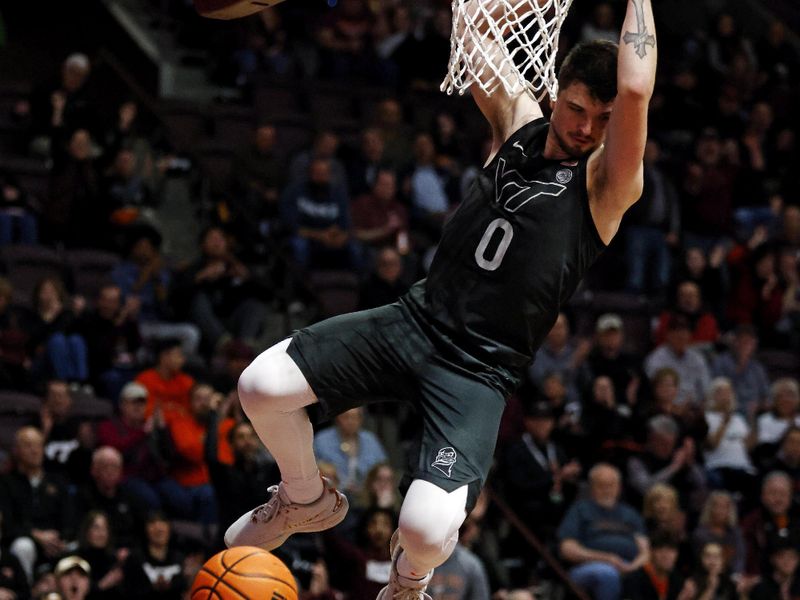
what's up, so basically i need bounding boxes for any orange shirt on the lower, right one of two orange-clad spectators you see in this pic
[164,410,234,486]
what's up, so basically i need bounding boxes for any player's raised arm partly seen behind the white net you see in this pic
[466,0,542,161]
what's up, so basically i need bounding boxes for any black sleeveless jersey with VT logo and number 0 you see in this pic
[404,119,605,385]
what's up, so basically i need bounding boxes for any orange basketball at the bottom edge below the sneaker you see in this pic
[189,546,297,600]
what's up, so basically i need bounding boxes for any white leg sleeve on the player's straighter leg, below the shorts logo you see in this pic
[397,479,468,579]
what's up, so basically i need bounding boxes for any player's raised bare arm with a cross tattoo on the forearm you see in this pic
[589,0,658,243]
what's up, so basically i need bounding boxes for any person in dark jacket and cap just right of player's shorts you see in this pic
[501,401,581,542]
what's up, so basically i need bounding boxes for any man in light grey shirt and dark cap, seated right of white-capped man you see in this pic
[644,314,711,403]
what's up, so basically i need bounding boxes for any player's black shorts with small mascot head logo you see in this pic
[287,302,507,511]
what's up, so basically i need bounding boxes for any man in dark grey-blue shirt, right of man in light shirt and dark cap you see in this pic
[711,325,769,416]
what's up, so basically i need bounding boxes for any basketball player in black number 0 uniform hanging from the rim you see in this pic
[225,0,656,600]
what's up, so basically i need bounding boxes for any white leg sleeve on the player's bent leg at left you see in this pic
[239,339,323,503]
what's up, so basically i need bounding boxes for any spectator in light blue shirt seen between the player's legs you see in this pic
[314,408,386,494]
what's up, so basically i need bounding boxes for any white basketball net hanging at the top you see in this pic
[441,0,572,101]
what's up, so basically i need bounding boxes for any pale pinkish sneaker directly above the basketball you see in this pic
[225,477,349,550]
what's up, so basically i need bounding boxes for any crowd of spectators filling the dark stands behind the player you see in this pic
[0,0,800,600]
